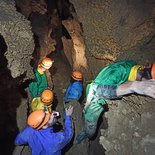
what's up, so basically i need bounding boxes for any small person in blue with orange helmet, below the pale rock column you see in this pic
[63,71,83,142]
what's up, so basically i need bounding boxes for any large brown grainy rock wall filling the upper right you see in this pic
[71,0,155,75]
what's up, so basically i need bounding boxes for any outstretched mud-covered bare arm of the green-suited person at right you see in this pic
[116,79,155,98]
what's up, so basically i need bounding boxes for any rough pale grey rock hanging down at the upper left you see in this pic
[0,0,34,78]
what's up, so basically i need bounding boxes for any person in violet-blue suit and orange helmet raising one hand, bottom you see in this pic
[15,106,73,155]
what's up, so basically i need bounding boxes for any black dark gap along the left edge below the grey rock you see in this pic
[0,35,21,155]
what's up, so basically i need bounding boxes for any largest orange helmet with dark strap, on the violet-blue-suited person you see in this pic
[27,110,50,130]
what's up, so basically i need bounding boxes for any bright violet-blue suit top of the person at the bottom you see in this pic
[15,116,73,155]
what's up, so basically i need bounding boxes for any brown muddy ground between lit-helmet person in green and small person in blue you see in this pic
[50,53,71,118]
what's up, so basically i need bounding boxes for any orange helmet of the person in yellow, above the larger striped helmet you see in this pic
[41,89,54,105]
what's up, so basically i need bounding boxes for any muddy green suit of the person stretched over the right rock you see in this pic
[76,60,139,143]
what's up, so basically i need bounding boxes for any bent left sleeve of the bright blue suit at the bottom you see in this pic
[15,127,33,145]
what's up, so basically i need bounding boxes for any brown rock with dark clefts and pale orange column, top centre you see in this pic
[16,0,89,77]
